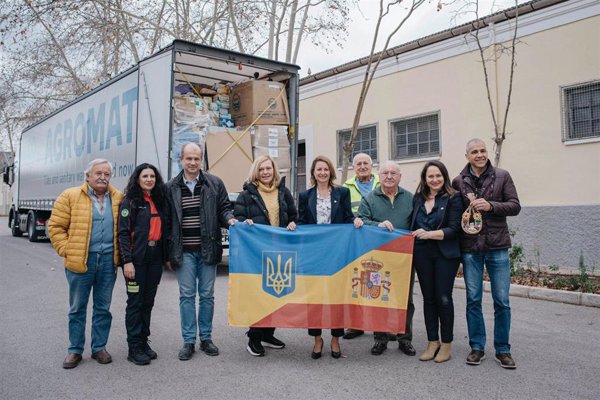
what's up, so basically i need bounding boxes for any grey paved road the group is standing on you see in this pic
[0,218,600,400]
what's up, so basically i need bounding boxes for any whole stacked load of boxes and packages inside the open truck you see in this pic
[173,80,290,192]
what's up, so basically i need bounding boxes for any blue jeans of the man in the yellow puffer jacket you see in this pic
[65,253,117,354]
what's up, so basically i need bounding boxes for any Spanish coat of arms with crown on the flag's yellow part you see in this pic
[352,258,392,301]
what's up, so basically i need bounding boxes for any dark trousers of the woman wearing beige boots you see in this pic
[413,241,460,343]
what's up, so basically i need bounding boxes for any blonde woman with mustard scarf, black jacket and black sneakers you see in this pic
[233,155,298,357]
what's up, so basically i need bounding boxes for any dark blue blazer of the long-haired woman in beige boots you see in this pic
[411,193,463,258]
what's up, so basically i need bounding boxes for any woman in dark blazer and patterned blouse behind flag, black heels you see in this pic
[298,156,363,360]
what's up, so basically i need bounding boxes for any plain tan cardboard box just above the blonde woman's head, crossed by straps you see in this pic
[206,126,253,192]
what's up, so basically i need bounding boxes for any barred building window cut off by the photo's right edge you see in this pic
[561,81,600,142]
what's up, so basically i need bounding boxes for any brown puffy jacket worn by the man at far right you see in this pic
[452,160,521,253]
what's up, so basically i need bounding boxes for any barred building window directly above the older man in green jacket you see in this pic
[391,113,440,160]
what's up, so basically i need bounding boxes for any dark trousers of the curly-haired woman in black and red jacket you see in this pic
[125,246,163,347]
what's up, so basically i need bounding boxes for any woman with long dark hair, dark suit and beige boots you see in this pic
[412,161,462,363]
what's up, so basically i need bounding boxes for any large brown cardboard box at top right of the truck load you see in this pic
[230,81,290,126]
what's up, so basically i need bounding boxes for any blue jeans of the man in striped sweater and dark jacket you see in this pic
[176,251,217,343]
